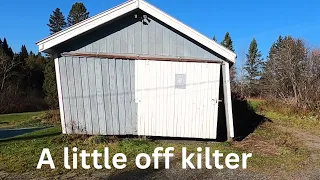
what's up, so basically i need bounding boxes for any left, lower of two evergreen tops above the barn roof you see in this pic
[47,8,67,34]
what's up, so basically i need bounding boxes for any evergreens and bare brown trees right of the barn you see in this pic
[219,33,320,111]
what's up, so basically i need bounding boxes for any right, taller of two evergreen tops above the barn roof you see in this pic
[68,2,89,26]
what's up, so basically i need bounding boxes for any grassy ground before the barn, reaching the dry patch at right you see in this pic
[0,101,318,175]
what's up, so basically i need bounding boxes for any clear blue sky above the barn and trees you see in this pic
[0,0,320,63]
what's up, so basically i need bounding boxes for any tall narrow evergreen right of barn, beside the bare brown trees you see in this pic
[244,38,263,95]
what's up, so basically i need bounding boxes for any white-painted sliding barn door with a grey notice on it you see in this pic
[135,61,220,139]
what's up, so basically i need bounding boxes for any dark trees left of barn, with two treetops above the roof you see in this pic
[0,2,89,114]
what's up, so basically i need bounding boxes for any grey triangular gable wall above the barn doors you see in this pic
[55,11,224,60]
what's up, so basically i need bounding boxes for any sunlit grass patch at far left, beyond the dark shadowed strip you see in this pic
[0,112,44,128]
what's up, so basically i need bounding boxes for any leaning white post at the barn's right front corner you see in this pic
[222,62,234,140]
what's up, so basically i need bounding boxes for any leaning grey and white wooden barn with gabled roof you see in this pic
[37,0,236,139]
